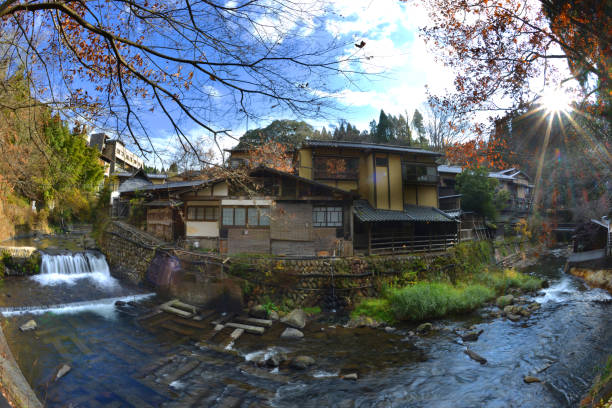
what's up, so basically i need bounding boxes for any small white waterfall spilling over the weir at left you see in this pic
[32,252,118,287]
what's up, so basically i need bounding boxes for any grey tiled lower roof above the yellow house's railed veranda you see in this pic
[353,200,455,222]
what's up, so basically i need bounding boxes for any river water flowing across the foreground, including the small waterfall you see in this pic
[0,244,612,407]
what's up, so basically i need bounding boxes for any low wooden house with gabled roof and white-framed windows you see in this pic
[122,167,355,256]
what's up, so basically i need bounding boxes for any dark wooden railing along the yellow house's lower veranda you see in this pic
[369,233,457,254]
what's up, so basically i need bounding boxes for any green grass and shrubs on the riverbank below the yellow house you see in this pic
[352,241,542,323]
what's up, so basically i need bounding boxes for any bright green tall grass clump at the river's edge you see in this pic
[385,282,495,321]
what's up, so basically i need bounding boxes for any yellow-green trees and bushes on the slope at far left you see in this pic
[0,70,104,240]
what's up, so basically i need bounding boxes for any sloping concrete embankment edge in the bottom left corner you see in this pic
[0,327,43,408]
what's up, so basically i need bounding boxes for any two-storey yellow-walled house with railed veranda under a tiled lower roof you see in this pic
[296,140,458,254]
